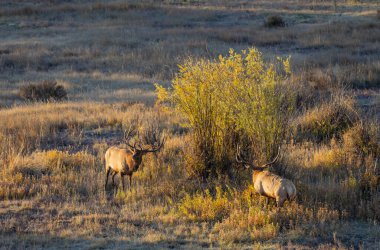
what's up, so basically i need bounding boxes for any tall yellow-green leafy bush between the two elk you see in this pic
[156,48,293,175]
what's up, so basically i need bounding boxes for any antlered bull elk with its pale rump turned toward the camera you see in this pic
[236,145,296,207]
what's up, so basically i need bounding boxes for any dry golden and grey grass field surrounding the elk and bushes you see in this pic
[0,0,380,249]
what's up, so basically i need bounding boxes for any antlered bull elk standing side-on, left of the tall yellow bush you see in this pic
[105,126,165,190]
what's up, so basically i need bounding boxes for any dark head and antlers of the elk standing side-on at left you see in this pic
[124,126,165,170]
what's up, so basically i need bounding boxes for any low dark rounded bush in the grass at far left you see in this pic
[19,81,67,102]
